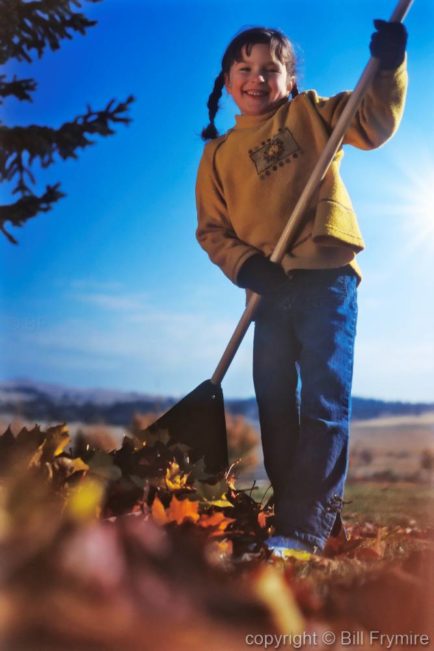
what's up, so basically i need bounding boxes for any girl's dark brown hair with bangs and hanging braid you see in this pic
[201,27,298,140]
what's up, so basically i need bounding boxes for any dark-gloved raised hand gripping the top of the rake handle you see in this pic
[369,19,407,70]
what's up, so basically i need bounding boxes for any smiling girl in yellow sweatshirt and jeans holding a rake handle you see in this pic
[196,21,407,554]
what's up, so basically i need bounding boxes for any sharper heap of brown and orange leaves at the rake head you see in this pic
[0,425,272,555]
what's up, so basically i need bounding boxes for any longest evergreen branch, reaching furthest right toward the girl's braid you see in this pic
[0,96,134,192]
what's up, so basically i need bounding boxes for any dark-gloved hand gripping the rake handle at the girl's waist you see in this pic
[237,253,288,295]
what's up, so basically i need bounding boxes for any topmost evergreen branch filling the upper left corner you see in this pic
[0,0,101,64]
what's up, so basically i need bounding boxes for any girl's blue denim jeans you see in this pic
[253,267,358,549]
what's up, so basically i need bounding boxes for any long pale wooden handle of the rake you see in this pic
[211,0,413,385]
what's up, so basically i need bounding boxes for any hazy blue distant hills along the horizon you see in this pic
[0,380,434,426]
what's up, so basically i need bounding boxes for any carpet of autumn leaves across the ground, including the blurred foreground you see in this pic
[0,426,432,651]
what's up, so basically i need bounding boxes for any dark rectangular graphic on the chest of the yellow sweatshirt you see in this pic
[249,127,301,179]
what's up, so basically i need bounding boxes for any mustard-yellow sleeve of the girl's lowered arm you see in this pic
[196,141,258,284]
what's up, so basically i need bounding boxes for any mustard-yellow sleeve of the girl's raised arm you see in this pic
[311,58,407,149]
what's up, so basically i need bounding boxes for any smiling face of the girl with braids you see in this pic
[225,43,294,115]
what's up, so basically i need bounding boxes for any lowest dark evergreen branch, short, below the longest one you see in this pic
[0,183,66,244]
